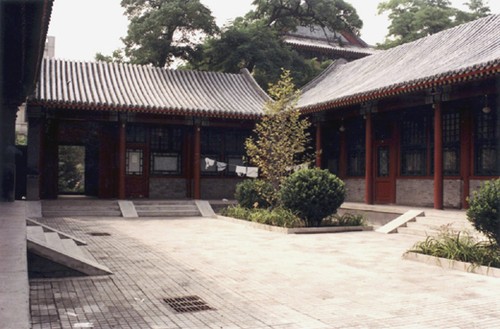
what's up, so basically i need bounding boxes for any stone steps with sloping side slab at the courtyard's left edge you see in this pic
[26,220,112,277]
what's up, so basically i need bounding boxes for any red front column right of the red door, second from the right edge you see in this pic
[434,102,443,209]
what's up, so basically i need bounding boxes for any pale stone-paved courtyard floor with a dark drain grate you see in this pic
[30,218,500,329]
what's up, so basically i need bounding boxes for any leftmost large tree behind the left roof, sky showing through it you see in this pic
[121,0,218,67]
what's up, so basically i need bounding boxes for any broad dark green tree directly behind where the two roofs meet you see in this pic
[188,18,331,89]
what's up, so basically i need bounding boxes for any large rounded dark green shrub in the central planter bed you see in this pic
[280,168,345,227]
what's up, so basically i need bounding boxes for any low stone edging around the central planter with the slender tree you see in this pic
[217,215,373,234]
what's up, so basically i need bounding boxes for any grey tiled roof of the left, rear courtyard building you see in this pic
[30,59,269,117]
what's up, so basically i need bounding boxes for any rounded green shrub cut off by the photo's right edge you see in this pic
[467,179,500,246]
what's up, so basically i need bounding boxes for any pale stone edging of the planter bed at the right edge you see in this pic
[403,252,500,278]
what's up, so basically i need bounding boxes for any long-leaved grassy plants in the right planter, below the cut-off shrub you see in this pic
[409,230,500,267]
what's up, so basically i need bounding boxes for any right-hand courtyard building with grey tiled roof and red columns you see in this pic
[299,15,500,208]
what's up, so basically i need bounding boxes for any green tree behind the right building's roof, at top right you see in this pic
[378,0,490,49]
